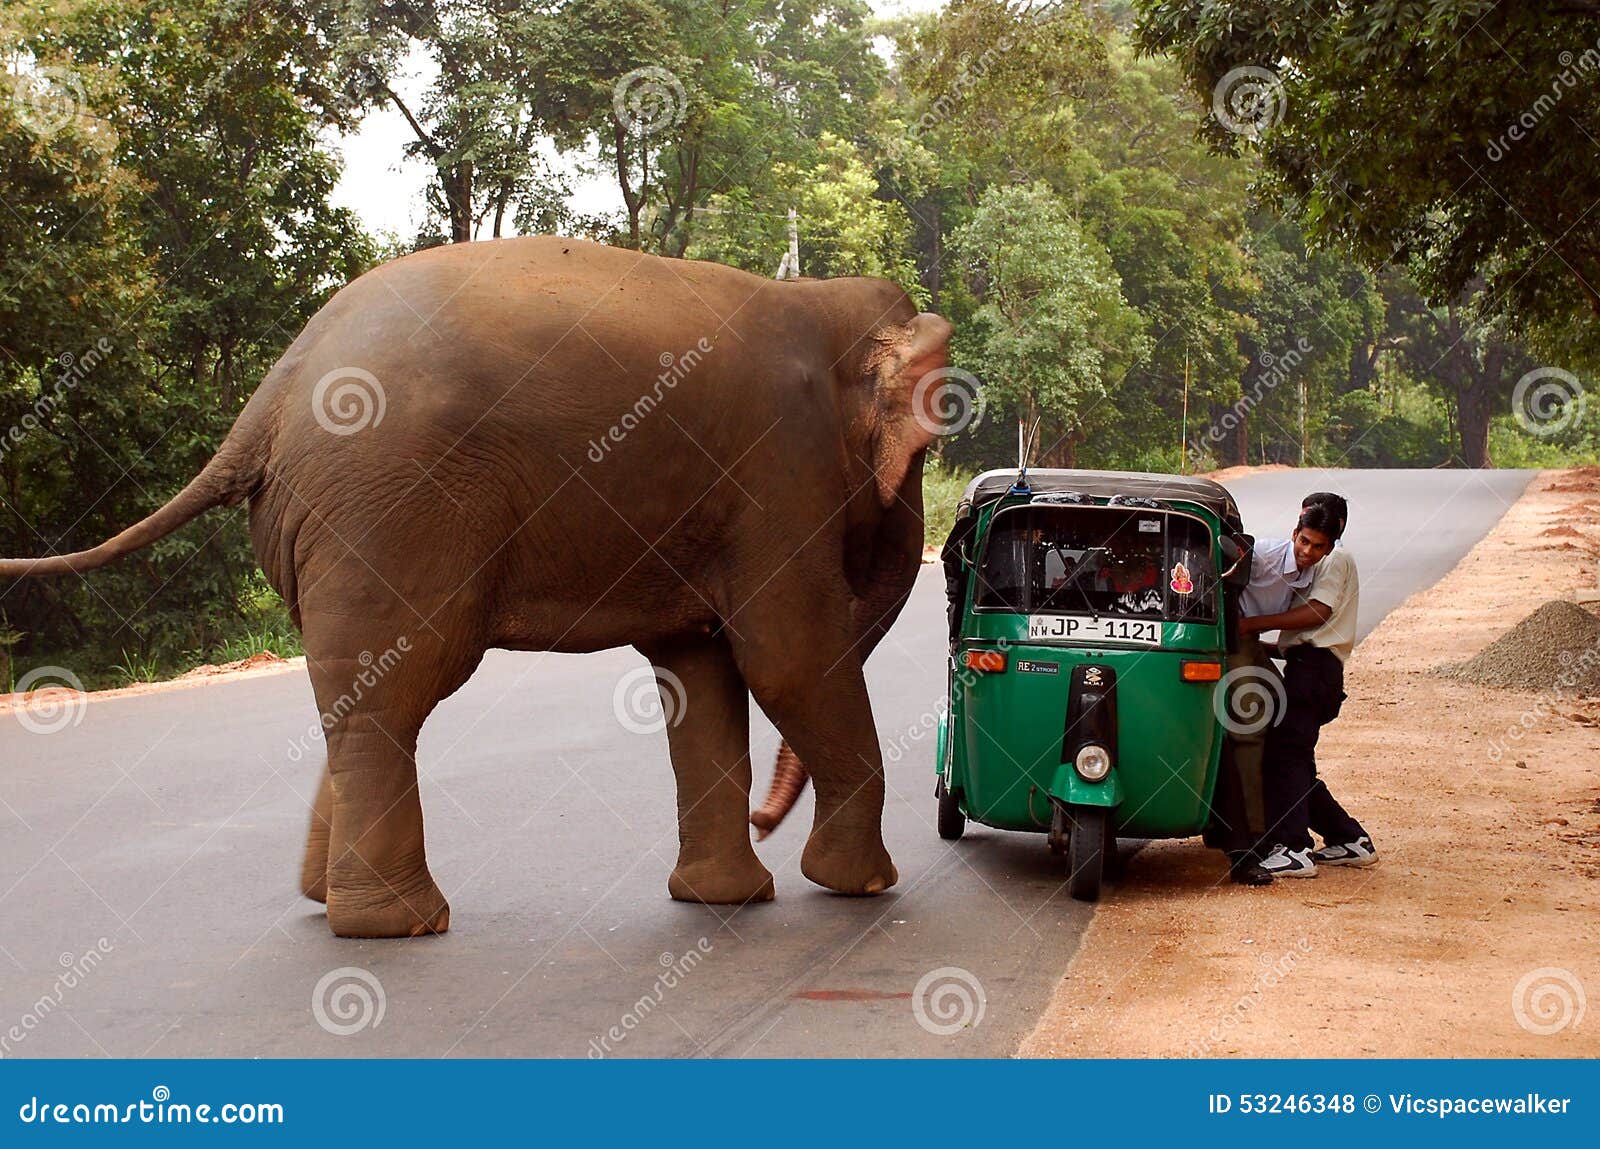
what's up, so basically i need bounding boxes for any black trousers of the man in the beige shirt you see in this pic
[1262,647,1366,850]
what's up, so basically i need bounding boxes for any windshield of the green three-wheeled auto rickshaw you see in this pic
[974,504,1216,623]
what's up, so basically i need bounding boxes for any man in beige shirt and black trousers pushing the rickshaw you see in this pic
[1245,493,1378,877]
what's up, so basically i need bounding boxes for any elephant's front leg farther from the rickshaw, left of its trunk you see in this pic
[643,635,773,904]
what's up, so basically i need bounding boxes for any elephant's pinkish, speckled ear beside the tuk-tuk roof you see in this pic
[869,312,950,507]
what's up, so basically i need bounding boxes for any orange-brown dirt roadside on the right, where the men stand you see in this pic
[1019,470,1600,1058]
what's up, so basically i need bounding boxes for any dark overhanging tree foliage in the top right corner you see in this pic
[1136,0,1600,331]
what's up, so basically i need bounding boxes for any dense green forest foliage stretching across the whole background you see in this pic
[0,0,1600,688]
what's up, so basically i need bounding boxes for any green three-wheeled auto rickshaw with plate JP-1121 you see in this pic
[934,470,1250,901]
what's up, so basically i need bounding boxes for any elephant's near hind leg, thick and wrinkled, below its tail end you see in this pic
[302,611,482,938]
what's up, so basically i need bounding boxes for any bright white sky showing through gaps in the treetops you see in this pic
[333,0,944,240]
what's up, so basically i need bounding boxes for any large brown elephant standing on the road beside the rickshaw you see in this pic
[0,237,950,938]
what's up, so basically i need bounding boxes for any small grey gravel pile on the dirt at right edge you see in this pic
[1443,600,1600,696]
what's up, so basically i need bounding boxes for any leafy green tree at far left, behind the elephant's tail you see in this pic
[0,0,371,678]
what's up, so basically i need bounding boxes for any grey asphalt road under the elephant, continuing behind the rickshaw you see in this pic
[0,470,1530,1058]
